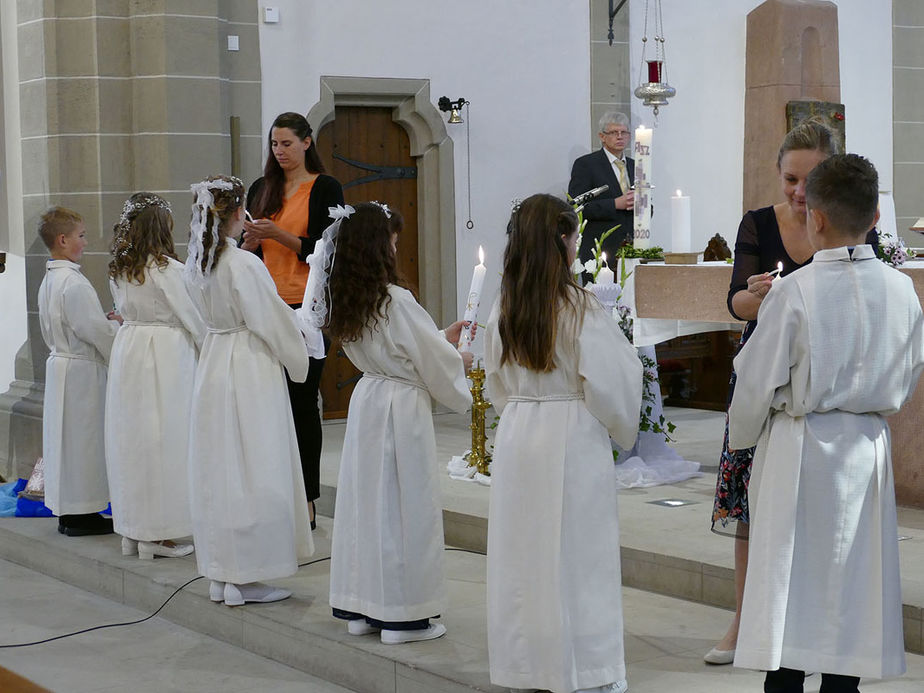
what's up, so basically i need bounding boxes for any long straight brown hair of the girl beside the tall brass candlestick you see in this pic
[498,195,586,373]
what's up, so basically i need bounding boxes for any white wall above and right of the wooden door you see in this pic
[260,0,590,346]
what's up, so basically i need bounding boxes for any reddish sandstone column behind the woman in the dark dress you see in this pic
[743,0,841,211]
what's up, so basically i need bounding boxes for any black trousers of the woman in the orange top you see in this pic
[286,303,330,501]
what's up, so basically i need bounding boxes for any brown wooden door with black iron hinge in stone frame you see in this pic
[317,106,420,419]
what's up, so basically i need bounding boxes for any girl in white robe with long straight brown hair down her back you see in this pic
[485,195,642,693]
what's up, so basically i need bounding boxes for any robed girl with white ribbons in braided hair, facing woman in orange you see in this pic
[186,176,314,606]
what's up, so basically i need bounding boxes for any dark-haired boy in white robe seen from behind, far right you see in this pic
[729,154,924,693]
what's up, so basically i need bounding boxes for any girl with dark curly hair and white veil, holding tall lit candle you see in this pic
[316,203,472,644]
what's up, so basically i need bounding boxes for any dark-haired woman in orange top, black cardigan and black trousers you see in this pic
[241,113,343,529]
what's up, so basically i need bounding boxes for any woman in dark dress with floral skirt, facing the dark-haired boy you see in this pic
[704,120,878,664]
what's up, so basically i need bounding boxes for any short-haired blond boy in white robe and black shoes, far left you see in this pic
[38,207,119,537]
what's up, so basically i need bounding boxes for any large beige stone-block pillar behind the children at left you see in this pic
[0,0,262,476]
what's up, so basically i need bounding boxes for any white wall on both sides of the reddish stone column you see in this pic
[629,0,892,253]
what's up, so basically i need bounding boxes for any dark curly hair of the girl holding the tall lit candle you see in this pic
[328,202,406,342]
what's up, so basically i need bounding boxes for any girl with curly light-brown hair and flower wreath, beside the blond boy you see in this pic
[106,192,205,559]
